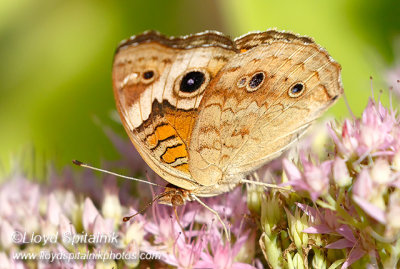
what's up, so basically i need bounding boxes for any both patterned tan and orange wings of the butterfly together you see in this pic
[113,30,343,204]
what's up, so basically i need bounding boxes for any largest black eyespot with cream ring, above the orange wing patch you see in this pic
[174,69,210,98]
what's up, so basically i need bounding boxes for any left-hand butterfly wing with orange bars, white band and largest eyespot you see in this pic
[113,32,235,190]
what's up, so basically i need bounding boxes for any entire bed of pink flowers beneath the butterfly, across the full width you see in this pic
[0,91,400,269]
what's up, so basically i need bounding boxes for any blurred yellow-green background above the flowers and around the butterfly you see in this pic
[0,0,400,178]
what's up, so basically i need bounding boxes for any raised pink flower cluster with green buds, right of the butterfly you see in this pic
[261,99,400,268]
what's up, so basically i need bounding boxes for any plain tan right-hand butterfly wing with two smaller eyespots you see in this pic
[189,31,343,186]
